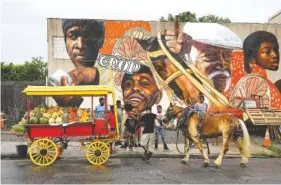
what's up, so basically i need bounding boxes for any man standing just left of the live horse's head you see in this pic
[155,105,169,150]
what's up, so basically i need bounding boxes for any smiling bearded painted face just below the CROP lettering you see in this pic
[122,73,159,112]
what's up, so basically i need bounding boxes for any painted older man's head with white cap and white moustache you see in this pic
[183,23,242,93]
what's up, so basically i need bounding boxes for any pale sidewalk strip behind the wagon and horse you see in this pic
[1,141,273,159]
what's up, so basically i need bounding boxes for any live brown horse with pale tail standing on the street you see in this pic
[166,104,250,167]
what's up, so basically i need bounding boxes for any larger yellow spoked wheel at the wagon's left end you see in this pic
[29,139,58,166]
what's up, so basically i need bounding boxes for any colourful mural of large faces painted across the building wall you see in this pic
[48,19,281,112]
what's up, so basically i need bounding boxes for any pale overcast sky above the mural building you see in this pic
[0,0,281,63]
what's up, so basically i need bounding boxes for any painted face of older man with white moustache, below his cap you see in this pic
[196,45,232,92]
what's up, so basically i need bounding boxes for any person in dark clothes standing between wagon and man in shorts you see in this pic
[125,114,138,151]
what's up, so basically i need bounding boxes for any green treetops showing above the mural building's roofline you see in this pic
[160,11,231,24]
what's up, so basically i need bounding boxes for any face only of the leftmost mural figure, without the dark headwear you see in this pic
[66,25,100,67]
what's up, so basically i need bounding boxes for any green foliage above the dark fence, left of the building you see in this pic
[1,57,48,81]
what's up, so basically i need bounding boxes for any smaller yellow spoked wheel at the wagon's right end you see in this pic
[86,141,110,165]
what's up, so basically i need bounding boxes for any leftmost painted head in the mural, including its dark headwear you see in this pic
[62,19,104,68]
